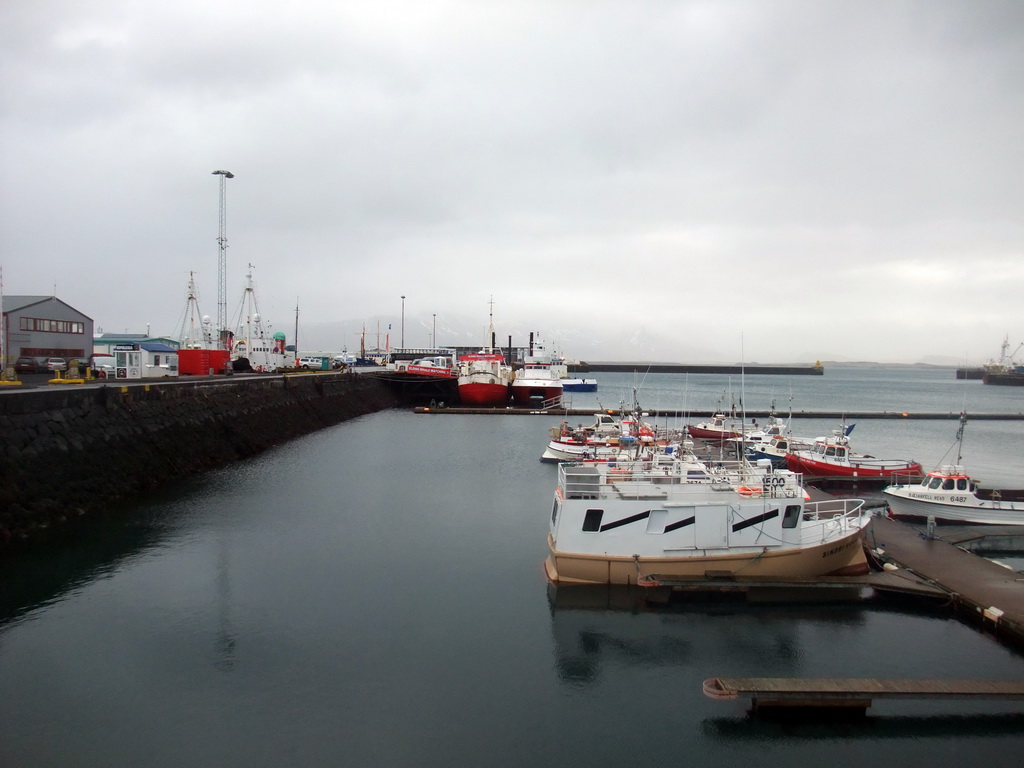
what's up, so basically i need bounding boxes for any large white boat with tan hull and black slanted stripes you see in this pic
[545,454,869,584]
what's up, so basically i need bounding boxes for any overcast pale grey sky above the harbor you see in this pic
[0,0,1024,362]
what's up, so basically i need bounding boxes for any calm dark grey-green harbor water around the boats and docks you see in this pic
[0,368,1024,768]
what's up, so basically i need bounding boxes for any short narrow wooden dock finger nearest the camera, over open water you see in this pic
[703,677,1024,710]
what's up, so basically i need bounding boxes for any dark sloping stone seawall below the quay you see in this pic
[0,373,400,548]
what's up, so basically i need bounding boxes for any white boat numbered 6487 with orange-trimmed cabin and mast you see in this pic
[882,415,1024,525]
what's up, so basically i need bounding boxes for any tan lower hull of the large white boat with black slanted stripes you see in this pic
[544,528,868,585]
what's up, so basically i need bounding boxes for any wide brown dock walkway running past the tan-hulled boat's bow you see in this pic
[867,517,1024,644]
